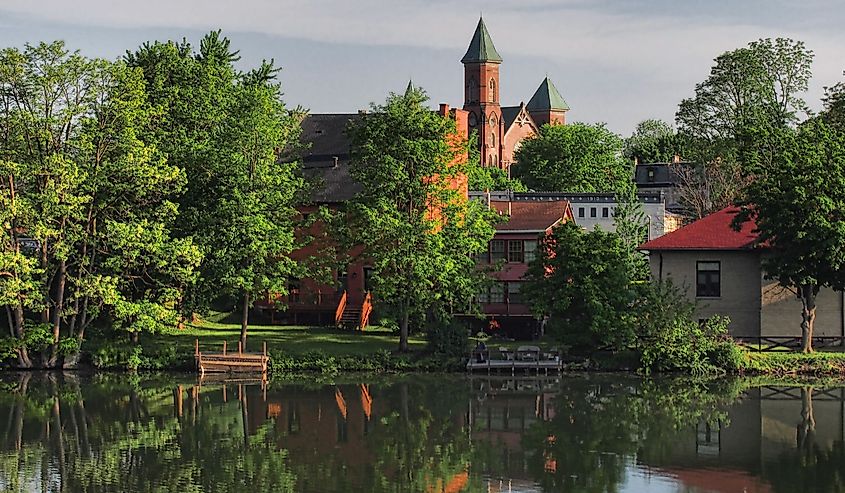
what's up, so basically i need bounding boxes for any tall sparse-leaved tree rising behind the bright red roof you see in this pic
[675,38,813,218]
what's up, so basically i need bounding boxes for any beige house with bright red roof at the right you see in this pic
[639,207,845,338]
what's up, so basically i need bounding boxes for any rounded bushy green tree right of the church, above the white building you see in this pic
[511,123,631,192]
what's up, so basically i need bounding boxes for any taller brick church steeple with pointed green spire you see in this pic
[461,18,503,166]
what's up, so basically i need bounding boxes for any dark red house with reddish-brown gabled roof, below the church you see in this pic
[468,200,574,339]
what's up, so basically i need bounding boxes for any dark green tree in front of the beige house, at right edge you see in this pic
[735,118,845,352]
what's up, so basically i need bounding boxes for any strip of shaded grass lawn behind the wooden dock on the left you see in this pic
[149,317,425,355]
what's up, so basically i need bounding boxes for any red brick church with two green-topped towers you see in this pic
[461,19,569,169]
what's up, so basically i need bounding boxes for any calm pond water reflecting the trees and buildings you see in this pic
[0,373,845,493]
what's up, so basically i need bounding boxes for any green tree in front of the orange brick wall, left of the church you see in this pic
[350,89,496,351]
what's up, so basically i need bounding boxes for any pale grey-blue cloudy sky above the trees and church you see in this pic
[0,0,845,136]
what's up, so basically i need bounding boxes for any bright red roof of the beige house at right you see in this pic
[639,207,757,250]
